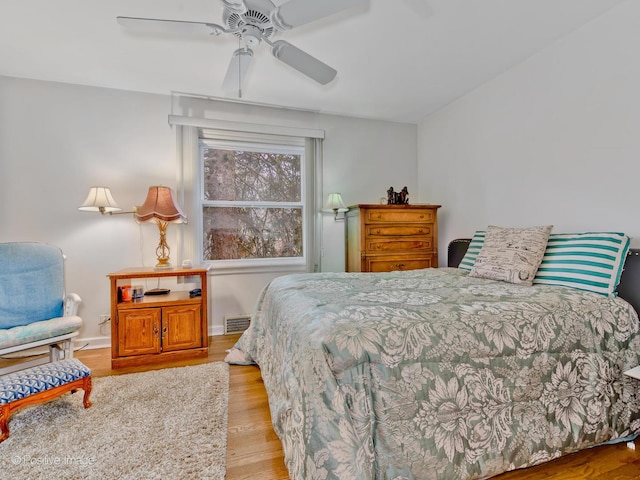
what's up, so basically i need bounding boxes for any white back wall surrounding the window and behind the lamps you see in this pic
[0,76,417,346]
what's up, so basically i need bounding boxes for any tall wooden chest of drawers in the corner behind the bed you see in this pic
[345,204,440,272]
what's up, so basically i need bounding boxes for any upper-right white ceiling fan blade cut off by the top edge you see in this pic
[271,0,365,31]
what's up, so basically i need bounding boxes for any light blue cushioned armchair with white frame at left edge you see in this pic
[0,242,82,375]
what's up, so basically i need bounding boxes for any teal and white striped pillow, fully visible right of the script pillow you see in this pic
[533,232,630,296]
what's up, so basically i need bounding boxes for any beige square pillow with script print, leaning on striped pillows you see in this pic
[469,225,552,286]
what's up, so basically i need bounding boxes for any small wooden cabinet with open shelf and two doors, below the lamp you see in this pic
[108,268,209,368]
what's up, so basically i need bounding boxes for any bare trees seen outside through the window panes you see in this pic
[202,147,303,260]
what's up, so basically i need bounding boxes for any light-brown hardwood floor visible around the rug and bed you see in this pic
[43,335,640,480]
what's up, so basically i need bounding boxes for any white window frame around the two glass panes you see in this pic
[197,136,311,270]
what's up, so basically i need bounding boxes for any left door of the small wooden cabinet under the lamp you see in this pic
[118,308,160,357]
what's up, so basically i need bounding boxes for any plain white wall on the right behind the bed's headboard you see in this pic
[418,1,640,265]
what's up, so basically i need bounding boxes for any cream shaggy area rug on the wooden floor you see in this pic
[0,362,229,480]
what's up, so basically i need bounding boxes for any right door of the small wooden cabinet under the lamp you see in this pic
[162,305,203,352]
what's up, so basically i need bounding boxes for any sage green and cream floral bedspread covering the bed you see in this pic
[236,268,640,480]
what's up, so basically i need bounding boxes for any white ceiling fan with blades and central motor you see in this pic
[117,0,365,97]
